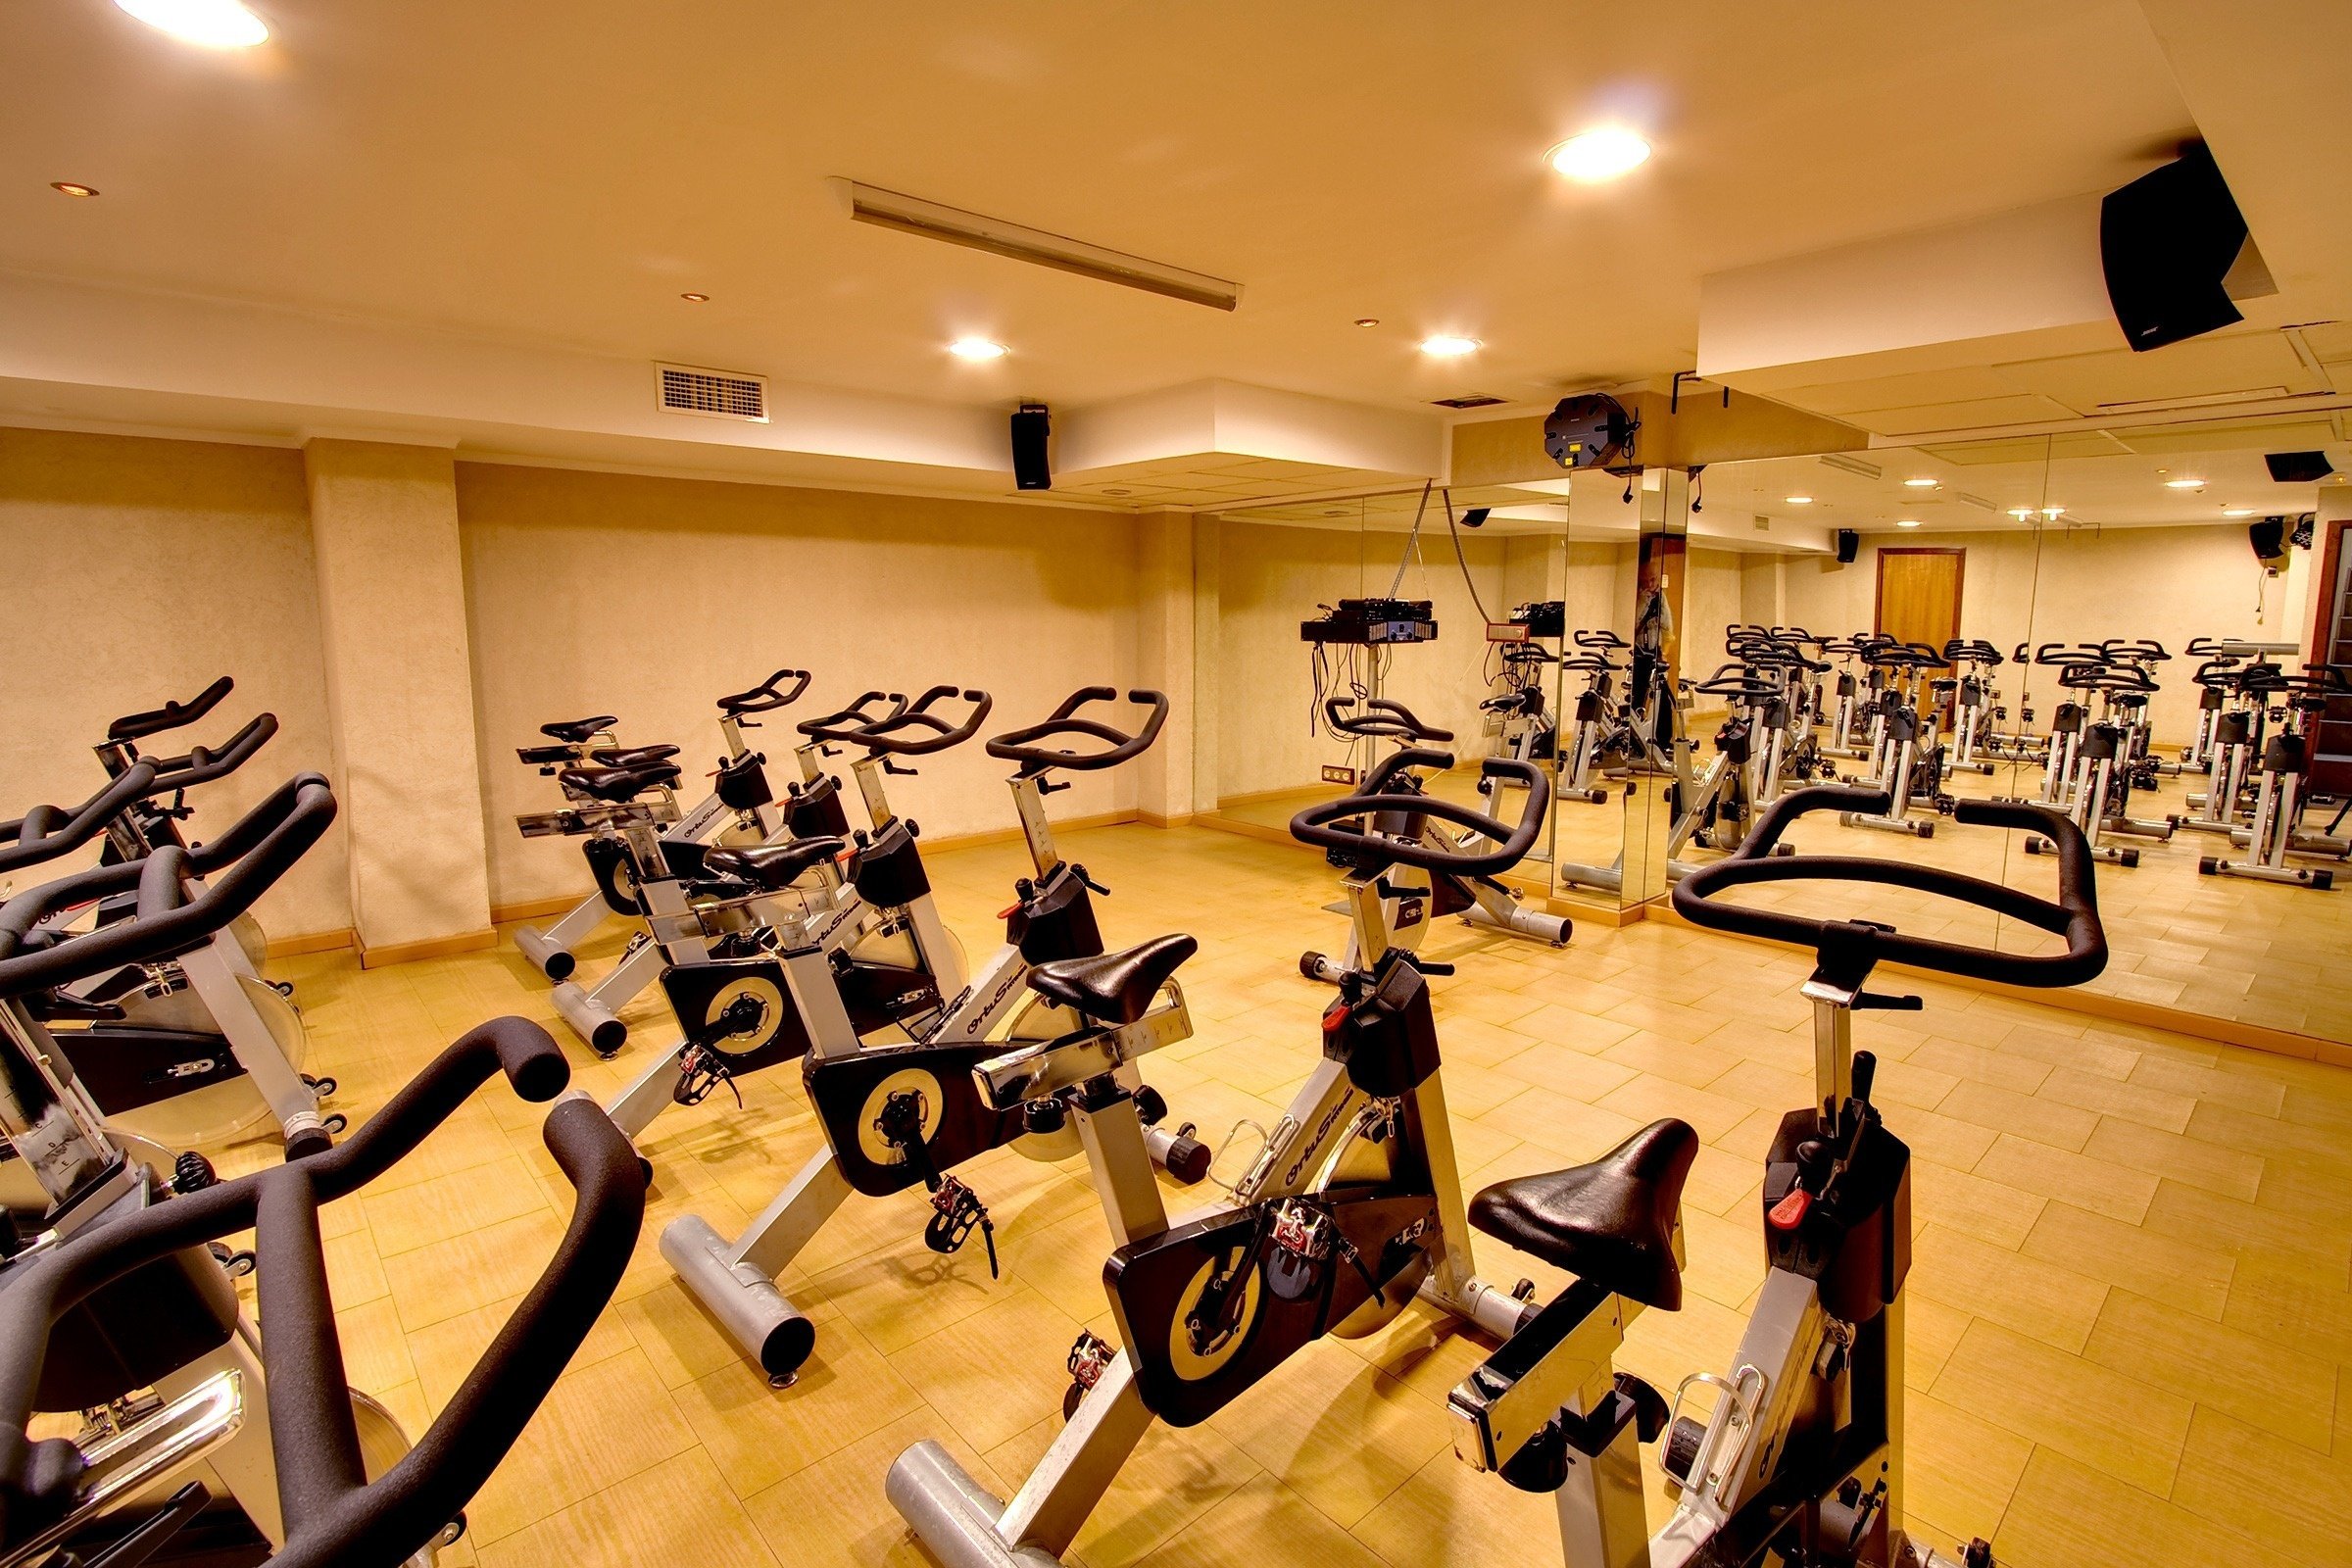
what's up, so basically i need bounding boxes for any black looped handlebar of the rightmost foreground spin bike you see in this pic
[1675,785,2107,987]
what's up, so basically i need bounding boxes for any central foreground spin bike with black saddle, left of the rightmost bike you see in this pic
[887,761,1547,1568]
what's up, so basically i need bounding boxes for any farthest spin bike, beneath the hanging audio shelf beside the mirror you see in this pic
[1298,698,1574,985]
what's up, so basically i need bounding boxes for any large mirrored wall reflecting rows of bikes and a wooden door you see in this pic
[1216,411,2352,1049]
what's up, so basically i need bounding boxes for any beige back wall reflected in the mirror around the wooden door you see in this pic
[1788,524,2303,745]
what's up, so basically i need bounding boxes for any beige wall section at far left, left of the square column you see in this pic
[0,428,351,938]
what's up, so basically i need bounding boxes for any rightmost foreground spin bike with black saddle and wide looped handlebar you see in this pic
[1439,788,2107,1568]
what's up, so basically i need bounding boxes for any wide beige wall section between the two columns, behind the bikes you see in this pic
[459,464,1139,906]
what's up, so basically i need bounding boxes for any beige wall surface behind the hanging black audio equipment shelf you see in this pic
[1201,517,1514,797]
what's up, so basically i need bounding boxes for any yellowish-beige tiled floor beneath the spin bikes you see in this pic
[207,827,2352,1568]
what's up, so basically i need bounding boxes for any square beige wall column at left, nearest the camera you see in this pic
[304,440,496,966]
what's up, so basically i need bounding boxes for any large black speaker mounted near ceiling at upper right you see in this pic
[2098,141,2246,350]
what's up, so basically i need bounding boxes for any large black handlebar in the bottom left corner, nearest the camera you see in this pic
[0,1018,645,1568]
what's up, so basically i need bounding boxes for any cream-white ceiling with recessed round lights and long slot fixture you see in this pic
[0,0,2352,506]
